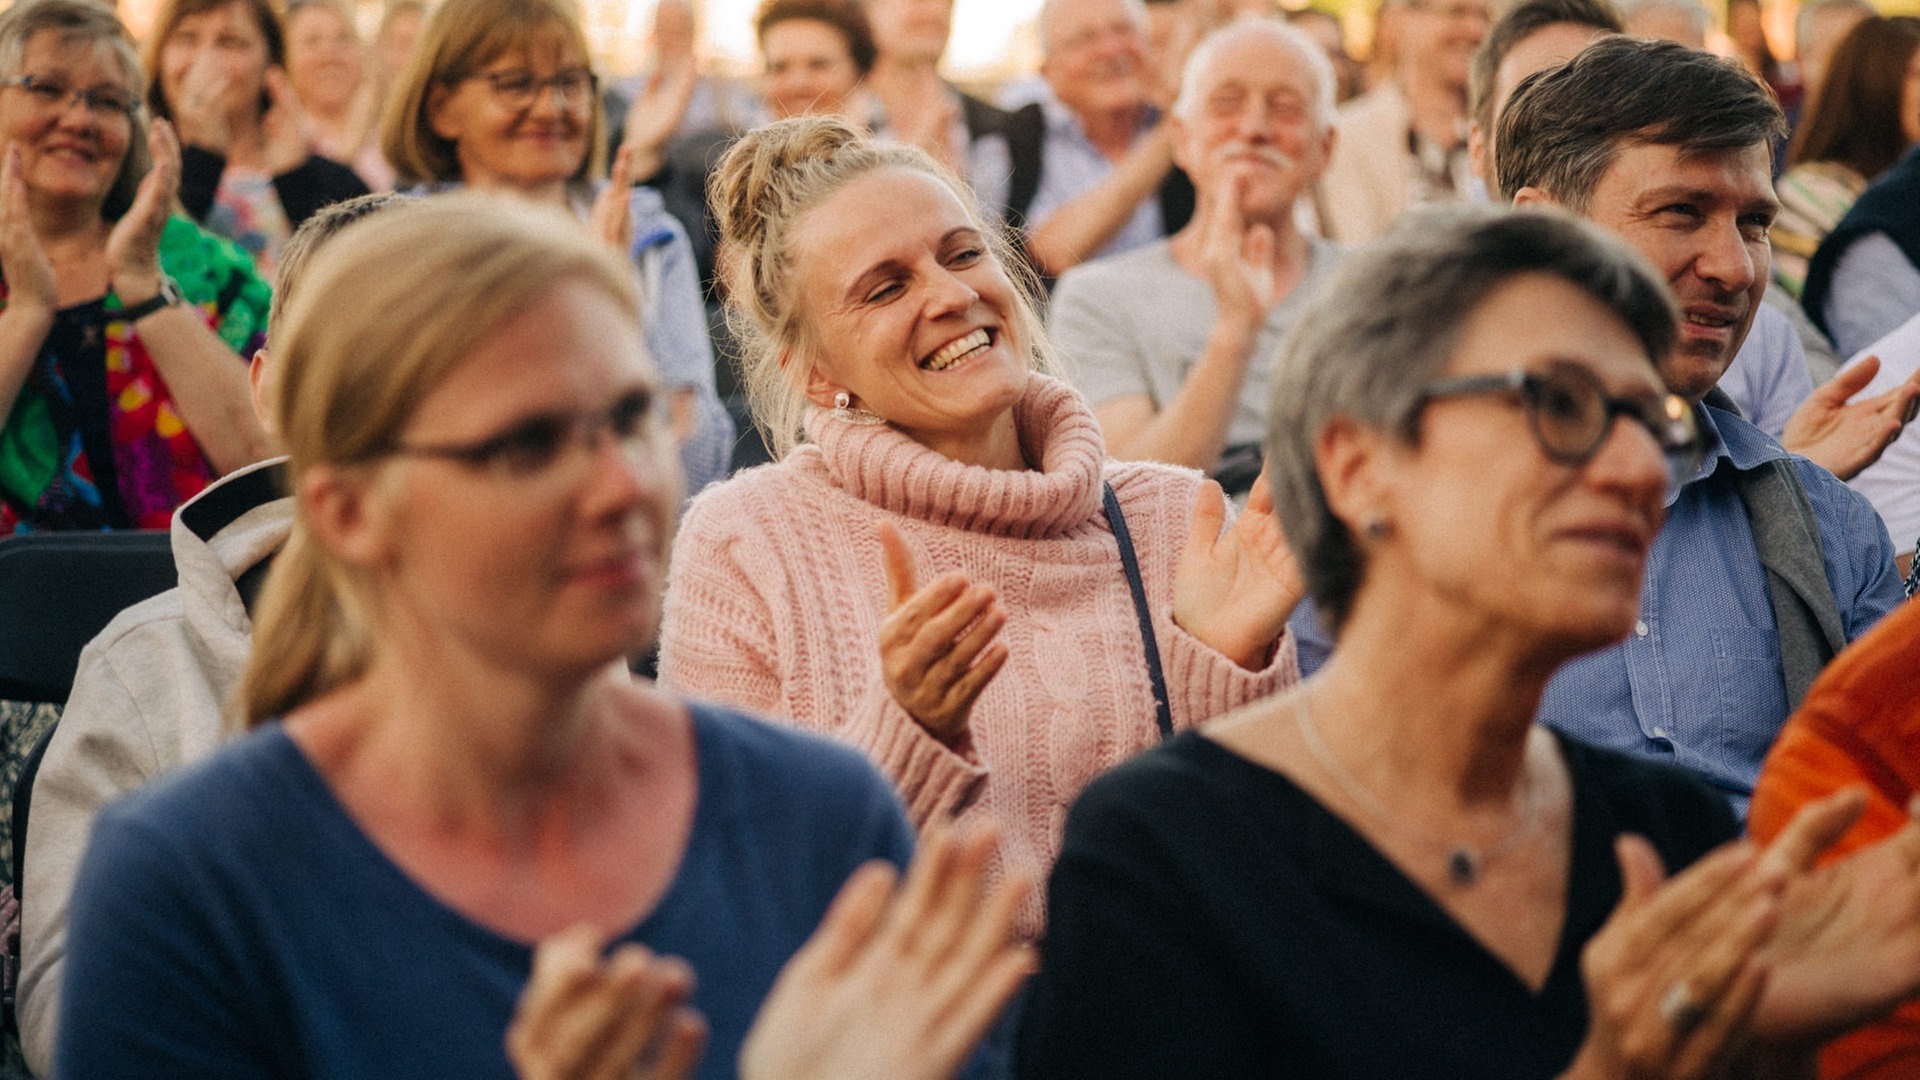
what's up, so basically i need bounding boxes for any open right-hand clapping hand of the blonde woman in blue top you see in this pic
[739,828,1033,1080]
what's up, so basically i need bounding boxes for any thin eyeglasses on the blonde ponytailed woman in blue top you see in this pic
[386,388,666,482]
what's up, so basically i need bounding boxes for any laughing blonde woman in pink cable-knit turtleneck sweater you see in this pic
[660,117,1302,936]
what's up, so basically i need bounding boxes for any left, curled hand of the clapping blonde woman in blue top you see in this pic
[507,926,707,1080]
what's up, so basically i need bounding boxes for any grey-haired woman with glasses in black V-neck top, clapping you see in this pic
[1020,211,1920,1080]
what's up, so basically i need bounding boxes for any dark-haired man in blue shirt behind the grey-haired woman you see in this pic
[1494,37,1905,801]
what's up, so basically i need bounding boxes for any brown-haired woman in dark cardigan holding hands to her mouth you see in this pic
[146,0,367,275]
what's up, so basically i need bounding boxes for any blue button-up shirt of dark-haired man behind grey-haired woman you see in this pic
[1288,405,1901,815]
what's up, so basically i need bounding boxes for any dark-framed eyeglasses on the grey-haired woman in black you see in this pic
[1415,363,1703,484]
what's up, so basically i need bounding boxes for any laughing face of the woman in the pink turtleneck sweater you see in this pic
[793,167,1031,461]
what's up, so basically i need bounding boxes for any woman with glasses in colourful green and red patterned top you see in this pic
[0,0,269,534]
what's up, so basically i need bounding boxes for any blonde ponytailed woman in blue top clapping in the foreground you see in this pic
[58,196,1025,1078]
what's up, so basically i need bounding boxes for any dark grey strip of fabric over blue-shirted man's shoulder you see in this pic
[1738,457,1847,709]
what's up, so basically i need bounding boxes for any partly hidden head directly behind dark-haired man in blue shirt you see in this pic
[1467,0,1622,186]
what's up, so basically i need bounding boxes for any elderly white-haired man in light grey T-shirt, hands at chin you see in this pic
[1050,17,1338,492]
